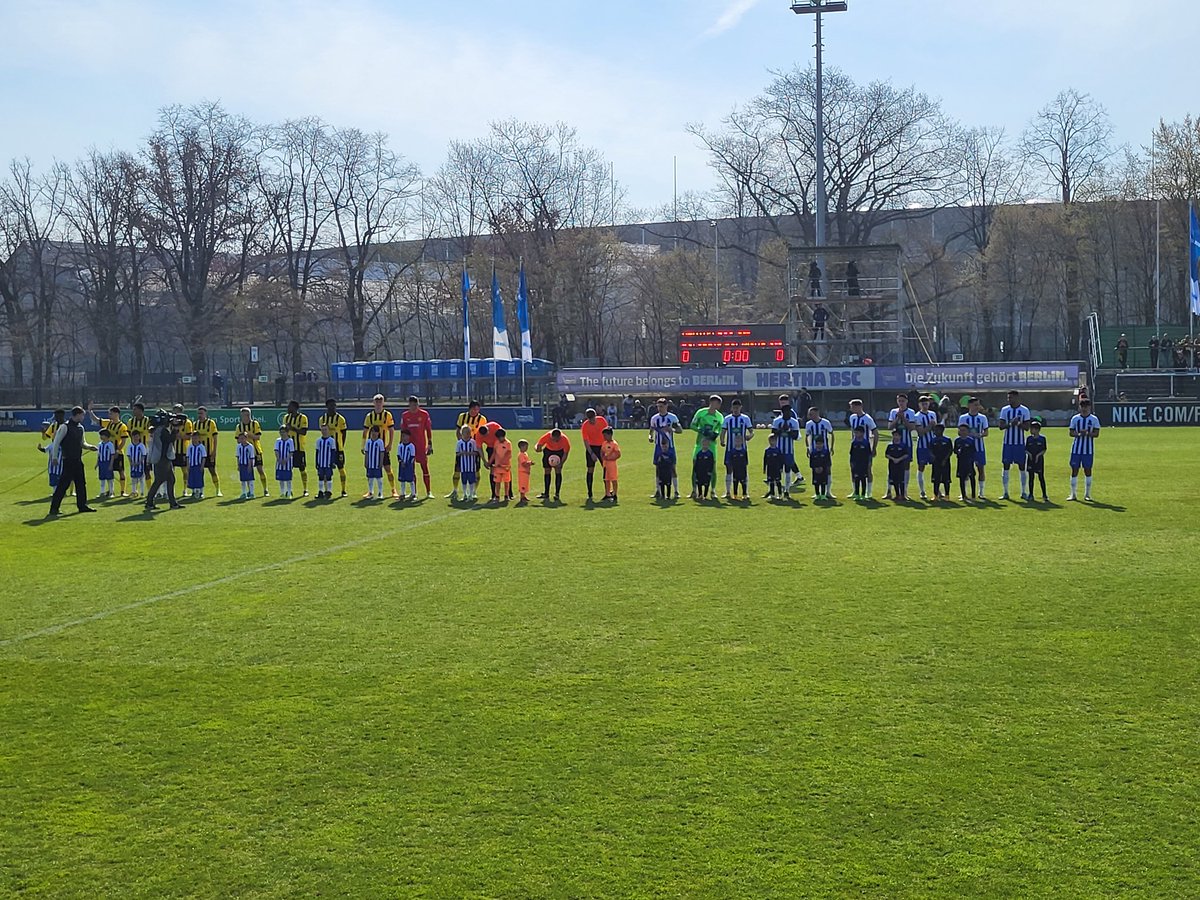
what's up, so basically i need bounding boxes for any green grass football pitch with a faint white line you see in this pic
[0,428,1200,898]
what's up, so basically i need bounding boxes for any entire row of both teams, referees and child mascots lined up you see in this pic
[38,391,1100,502]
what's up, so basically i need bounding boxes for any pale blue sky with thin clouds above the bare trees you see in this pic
[0,0,1200,208]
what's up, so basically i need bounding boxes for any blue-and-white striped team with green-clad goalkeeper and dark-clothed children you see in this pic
[648,390,1100,500]
